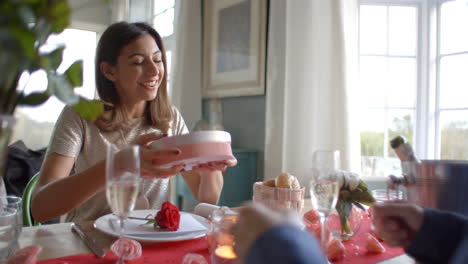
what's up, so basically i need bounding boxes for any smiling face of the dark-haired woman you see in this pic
[112,34,165,105]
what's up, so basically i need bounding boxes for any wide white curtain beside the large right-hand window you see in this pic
[265,0,360,186]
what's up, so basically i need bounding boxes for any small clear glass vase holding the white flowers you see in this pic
[327,205,364,240]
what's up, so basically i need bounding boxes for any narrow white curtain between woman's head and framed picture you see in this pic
[170,0,203,130]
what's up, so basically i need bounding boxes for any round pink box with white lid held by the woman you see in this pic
[151,131,234,171]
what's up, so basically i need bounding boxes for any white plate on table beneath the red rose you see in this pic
[94,210,208,242]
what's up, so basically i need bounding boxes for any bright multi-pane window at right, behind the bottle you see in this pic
[359,0,468,177]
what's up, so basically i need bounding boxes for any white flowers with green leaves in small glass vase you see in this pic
[335,171,375,237]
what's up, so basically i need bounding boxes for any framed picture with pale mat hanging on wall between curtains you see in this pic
[203,0,267,98]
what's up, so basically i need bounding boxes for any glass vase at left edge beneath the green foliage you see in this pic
[0,114,16,196]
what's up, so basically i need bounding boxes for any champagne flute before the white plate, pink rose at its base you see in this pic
[106,144,141,264]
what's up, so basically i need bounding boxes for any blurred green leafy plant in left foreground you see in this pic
[0,0,103,193]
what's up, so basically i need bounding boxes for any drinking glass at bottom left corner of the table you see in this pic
[0,195,23,260]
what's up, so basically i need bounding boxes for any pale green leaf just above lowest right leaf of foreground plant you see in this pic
[47,71,80,105]
